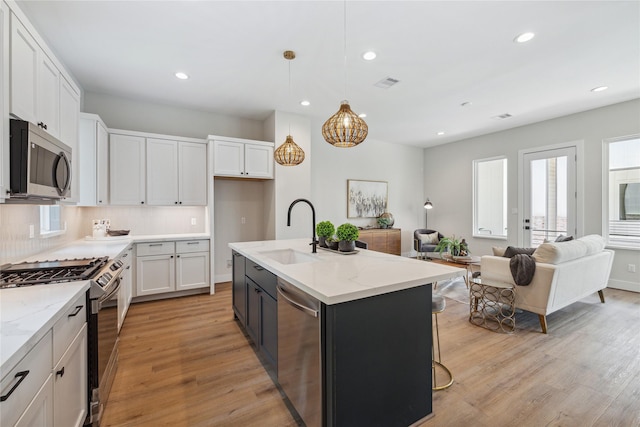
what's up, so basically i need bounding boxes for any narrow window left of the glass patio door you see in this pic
[473,157,507,239]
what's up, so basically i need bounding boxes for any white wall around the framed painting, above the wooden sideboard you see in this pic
[311,120,424,255]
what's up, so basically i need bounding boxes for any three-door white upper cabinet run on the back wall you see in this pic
[109,131,208,206]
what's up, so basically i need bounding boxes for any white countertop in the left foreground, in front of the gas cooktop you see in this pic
[0,280,89,378]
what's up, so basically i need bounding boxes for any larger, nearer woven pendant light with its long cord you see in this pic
[322,0,369,148]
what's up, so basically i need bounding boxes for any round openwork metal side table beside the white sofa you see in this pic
[469,277,516,334]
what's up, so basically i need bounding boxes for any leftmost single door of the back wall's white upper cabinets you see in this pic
[109,134,146,205]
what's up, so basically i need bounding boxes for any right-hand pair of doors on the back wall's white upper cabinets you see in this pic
[147,138,207,206]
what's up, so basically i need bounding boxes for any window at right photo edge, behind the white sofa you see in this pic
[602,135,640,249]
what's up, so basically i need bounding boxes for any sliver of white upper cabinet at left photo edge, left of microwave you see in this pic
[0,2,10,203]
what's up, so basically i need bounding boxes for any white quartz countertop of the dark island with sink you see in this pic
[229,239,466,304]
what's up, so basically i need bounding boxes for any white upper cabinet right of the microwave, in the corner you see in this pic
[79,113,109,206]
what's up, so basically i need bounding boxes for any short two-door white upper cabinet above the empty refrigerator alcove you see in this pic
[209,135,273,179]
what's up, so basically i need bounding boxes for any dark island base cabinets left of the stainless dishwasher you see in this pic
[232,253,278,372]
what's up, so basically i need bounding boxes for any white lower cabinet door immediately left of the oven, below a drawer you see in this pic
[53,324,88,427]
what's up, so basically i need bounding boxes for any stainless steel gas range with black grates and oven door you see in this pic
[0,257,124,426]
